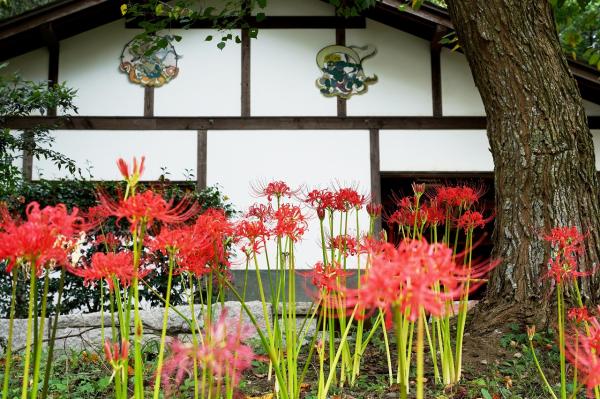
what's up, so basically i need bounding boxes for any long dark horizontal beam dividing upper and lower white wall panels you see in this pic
[4,116,492,130]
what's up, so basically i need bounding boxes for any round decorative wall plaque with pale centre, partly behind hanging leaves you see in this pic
[119,35,179,87]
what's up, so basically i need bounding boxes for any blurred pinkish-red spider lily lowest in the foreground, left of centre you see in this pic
[162,311,256,394]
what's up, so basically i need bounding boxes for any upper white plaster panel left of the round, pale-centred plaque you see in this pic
[59,19,144,116]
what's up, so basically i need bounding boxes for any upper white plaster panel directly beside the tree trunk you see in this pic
[441,48,485,116]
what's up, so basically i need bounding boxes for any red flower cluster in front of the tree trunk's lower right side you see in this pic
[544,227,590,284]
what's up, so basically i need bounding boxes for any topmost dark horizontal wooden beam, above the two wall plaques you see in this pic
[125,16,367,29]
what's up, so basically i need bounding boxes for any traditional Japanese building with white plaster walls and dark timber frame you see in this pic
[0,0,600,268]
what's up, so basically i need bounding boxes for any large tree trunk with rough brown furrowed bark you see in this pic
[447,0,600,328]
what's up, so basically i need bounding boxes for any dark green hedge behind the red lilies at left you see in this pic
[0,180,234,317]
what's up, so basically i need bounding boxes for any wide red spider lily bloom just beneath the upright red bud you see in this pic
[99,190,199,230]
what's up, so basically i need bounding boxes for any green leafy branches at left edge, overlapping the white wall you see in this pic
[0,64,77,198]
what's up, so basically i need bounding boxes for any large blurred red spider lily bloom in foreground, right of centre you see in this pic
[348,239,463,321]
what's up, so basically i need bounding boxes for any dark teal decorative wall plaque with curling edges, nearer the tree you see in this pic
[316,45,377,98]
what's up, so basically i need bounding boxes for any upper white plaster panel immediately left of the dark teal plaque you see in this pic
[251,29,337,116]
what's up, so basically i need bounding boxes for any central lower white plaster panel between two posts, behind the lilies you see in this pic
[207,130,370,268]
